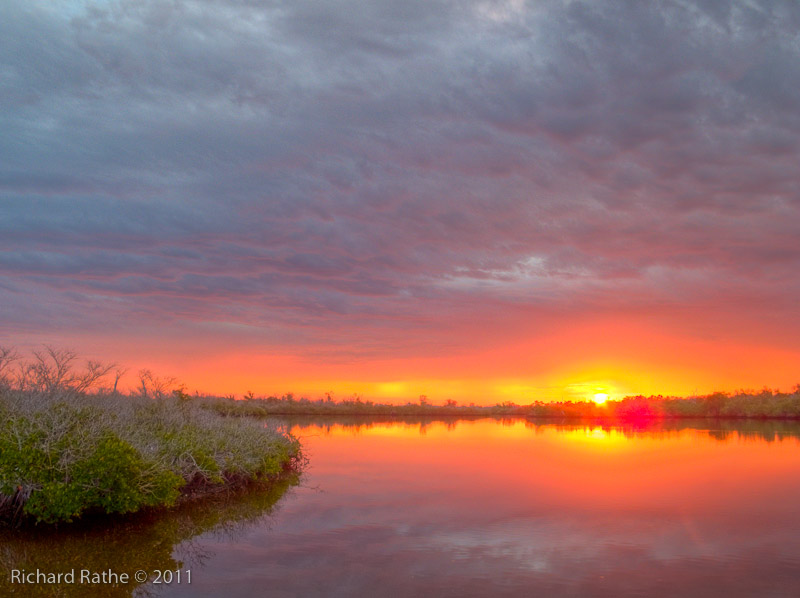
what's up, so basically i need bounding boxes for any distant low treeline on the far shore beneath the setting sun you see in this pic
[202,385,800,420]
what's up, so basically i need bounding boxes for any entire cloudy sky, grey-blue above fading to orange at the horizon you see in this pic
[0,0,800,404]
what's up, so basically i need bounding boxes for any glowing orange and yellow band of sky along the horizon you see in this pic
[34,319,800,405]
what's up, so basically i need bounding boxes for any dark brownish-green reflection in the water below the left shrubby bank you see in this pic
[0,475,299,598]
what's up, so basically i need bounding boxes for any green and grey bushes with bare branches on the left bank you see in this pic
[0,348,300,523]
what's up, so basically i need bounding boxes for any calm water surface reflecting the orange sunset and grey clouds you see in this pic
[0,419,800,598]
